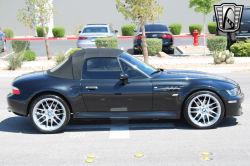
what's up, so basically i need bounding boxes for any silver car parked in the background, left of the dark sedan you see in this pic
[77,24,118,48]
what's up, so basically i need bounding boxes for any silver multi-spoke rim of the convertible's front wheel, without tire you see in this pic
[188,94,221,127]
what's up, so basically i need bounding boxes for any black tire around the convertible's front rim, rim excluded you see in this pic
[183,91,225,129]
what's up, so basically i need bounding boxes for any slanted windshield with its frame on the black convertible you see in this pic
[119,52,157,78]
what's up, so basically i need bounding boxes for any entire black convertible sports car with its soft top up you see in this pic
[7,49,244,133]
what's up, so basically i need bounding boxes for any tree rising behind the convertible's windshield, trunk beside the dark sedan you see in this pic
[116,0,163,63]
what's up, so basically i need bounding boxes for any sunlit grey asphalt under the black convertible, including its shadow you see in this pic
[0,73,250,166]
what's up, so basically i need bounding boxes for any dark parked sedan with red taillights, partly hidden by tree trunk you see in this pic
[133,23,174,54]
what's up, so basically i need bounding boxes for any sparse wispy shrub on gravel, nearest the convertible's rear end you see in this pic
[7,53,23,70]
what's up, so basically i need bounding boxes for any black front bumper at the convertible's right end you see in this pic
[224,93,244,117]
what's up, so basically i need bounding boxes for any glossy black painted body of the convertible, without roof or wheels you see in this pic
[7,65,244,119]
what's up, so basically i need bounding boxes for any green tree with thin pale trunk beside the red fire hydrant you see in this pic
[189,0,221,56]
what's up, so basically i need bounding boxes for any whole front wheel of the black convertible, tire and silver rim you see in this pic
[184,91,225,129]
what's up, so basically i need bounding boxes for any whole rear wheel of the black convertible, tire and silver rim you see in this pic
[30,95,70,134]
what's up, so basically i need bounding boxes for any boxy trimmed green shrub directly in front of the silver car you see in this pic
[95,38,118,49]
